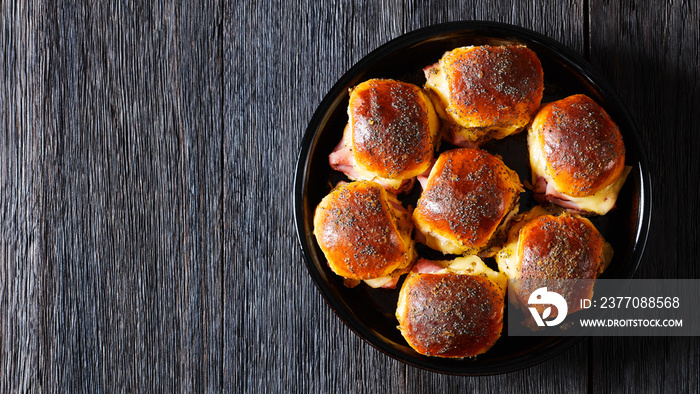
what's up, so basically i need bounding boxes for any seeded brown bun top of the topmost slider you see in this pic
[440,45,544,125]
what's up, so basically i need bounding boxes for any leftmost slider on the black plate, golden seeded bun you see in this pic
[314,181,417,288]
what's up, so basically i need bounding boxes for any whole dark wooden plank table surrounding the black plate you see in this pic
[0,0,700,393]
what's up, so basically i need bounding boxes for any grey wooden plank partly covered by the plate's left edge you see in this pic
[224,2,405,393]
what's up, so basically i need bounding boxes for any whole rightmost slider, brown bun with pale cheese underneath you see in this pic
[527,94,631,215]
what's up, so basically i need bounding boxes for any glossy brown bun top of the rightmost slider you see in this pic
[532,94,625,197]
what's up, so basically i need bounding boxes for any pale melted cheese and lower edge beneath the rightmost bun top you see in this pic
[528,132,632,215]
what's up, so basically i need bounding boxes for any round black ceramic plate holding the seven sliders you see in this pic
[294,22,651,375]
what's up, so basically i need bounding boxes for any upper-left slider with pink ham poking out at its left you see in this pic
[328,79,440,193]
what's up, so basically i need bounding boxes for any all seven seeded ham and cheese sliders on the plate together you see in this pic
[314,45,629,358]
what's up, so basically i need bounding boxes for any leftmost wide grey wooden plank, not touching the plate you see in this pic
[0,2,222,392]
